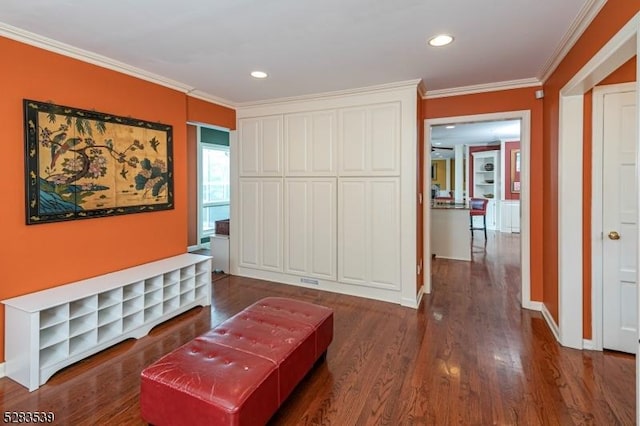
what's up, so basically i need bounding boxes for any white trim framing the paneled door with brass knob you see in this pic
[591,83,637,351]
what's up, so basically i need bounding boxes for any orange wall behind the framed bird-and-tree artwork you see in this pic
[0,37,235,358]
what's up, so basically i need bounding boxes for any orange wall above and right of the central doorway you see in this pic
[422,87,547,301]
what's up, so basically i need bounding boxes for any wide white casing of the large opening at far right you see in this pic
[557,13,640,352]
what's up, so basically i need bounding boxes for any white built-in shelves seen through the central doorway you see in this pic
[471,150,501,230]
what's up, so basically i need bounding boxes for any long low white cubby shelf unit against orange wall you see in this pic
[2,254,211,391]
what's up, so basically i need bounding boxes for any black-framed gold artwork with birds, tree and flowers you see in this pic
[24,99,173,225]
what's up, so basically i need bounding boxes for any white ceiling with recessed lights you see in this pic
[0,0,594,104]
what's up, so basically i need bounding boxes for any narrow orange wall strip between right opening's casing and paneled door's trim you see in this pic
[582,56,636,339]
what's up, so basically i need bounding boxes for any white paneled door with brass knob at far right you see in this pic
[602,92,638,353]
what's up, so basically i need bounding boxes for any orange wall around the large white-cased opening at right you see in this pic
[542,0,640,323]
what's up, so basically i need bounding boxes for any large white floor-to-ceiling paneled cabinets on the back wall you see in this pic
[231,83,417,304]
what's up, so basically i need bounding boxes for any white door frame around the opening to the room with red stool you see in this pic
[423,110,542,311]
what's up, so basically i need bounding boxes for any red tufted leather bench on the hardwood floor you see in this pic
[140,297,333,426]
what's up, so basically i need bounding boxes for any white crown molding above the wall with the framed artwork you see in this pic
[0,22,235,108]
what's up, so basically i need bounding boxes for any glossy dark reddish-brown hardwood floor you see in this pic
[0,233,635,426]
